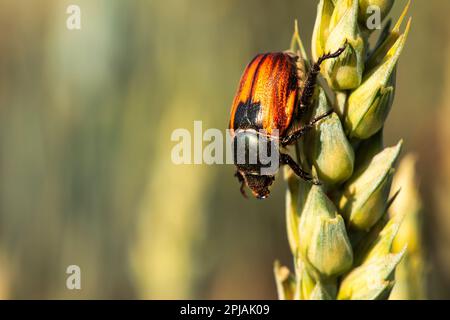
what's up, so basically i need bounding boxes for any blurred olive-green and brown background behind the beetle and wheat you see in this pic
[0,0,450,299]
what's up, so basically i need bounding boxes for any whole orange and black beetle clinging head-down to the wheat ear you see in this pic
[229,45,346,199]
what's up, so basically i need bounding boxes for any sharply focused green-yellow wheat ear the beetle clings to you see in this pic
[274,0,411,299]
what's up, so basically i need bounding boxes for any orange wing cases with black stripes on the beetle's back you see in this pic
[229,52,299,136]
